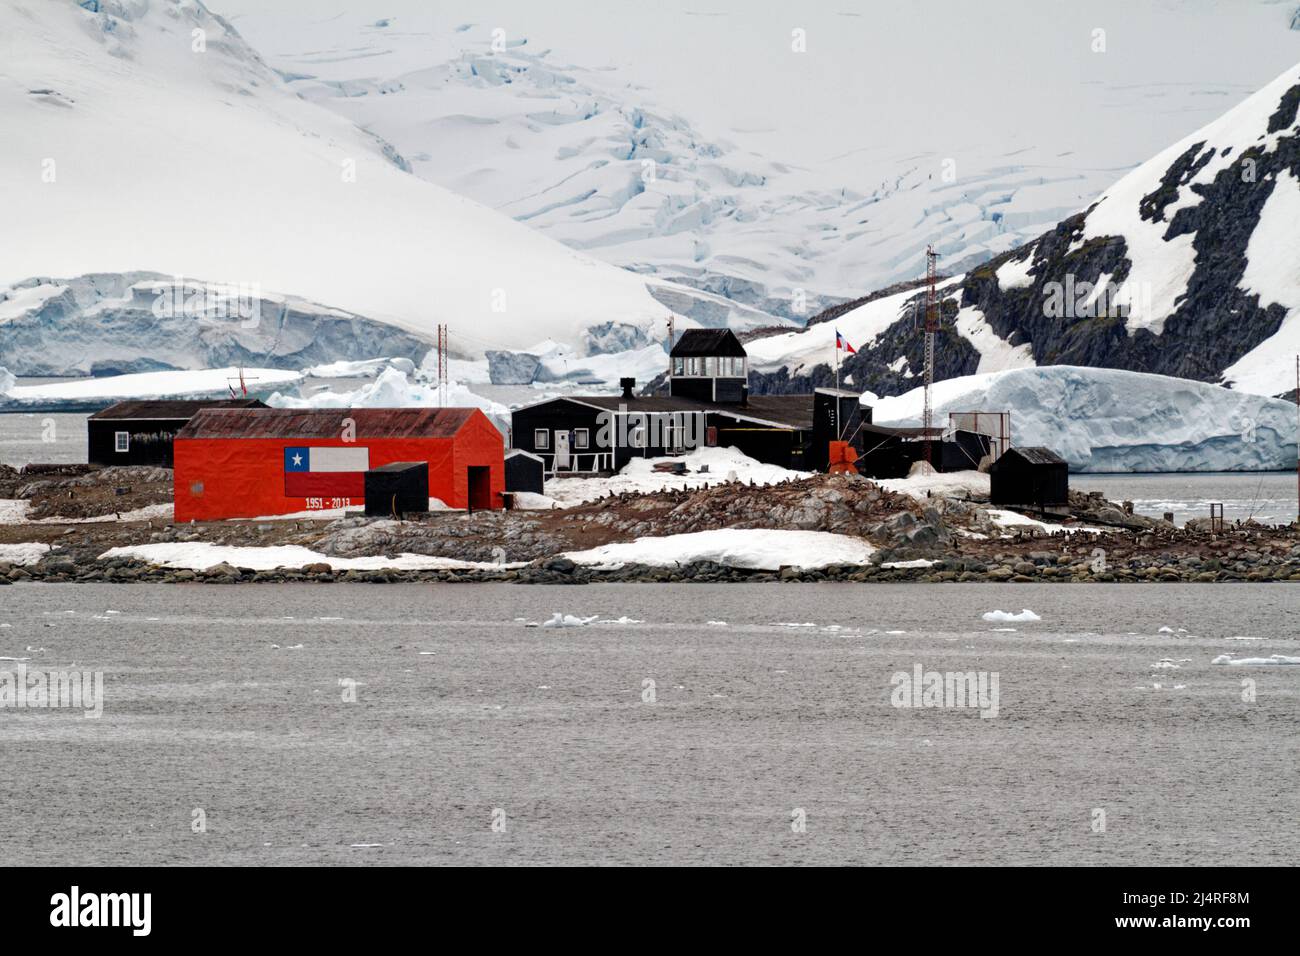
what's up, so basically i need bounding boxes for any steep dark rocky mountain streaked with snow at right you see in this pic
[750,56,1300,395]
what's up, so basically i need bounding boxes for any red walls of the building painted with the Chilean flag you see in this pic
[174,415,506,523]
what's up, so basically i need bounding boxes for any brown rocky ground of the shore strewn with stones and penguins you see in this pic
[0,467,1300,584]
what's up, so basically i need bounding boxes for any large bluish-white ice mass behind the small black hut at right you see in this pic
[872,365,1296,472]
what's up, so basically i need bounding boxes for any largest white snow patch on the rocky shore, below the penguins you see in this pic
[564,528,875,571]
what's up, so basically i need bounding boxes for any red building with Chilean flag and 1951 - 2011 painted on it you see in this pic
[174,408,506,523]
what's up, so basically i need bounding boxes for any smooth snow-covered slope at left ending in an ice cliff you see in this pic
[0,0,785,373]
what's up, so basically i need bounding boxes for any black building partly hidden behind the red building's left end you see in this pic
[86,398,267,468]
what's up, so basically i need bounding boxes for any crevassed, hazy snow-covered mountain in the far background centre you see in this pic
[213,0,1300,319]
